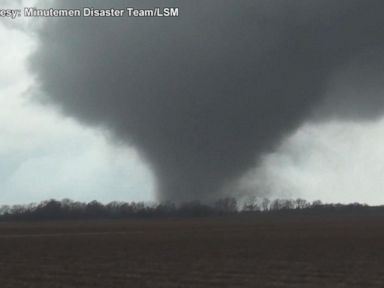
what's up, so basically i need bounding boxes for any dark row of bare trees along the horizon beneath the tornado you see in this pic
[0,197,384,221]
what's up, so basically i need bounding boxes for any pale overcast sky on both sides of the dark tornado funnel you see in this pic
[0,2,384,204]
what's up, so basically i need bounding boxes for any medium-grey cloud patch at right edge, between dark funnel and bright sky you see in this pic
[312,47,384,121]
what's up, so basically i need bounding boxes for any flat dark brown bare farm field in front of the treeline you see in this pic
[0,215,384,288]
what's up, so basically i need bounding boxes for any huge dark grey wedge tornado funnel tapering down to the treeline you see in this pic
[32,0,384,201]
